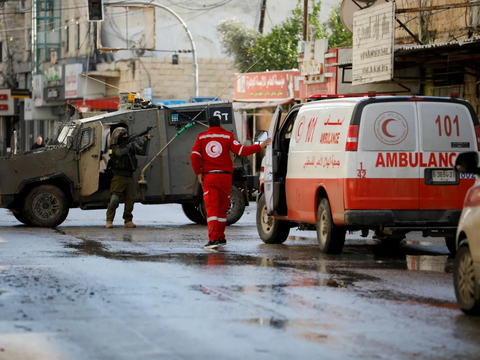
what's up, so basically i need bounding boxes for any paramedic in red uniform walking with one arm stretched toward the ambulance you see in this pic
[190,116,272,249]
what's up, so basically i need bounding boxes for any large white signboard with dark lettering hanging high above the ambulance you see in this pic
[352,2,395,86]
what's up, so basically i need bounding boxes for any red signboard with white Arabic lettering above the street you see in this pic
[234,70,300,101]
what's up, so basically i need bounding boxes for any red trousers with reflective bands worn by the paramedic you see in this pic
[203,174,232,241]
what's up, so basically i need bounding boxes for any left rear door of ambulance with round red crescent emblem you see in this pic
[352,98,420,210]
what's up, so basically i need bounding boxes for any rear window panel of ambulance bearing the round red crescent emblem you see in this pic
[359,101,417,151]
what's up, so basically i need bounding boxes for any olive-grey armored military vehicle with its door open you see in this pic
[0,102,254,227]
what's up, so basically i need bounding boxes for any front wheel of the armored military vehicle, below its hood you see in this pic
[23,185,69,227]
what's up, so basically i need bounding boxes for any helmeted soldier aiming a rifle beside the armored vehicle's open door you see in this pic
[106,127,150,228]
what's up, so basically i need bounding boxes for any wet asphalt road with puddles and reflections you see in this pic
[0,205,480,360]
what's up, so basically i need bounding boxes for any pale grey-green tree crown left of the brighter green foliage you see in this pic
[216,18,259,71]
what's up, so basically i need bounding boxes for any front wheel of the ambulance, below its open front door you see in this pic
[257,194,290,244]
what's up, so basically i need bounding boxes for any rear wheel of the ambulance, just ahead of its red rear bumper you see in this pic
[317,198,346,254]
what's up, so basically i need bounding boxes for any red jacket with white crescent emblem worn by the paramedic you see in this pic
[190,126,261,175]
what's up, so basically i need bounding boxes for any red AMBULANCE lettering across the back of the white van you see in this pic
[375,152,457,168]
